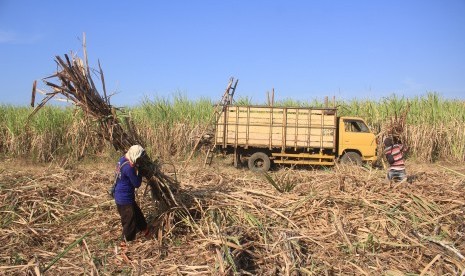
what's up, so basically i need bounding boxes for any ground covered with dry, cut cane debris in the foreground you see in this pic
[0,160,465,275]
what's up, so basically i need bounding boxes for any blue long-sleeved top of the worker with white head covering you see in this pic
[115,156,142,205]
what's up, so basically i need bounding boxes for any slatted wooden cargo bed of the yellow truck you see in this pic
[215,106,337,152]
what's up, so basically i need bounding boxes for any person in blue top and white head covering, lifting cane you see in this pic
[115,145,149,247]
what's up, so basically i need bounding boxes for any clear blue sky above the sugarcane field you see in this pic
[0,0,465,106]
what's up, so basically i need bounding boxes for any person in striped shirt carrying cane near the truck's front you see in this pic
[384,136,407,182]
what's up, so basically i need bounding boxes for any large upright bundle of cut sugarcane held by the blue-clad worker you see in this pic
[30,42,178,212]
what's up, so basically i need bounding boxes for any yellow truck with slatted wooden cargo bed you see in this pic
[214,105,377,172]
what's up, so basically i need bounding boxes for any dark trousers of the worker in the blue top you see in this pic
[116,202,147,241]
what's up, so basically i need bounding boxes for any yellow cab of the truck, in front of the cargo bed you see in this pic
[339,118,376,161]
